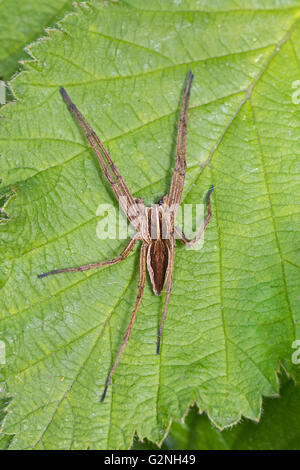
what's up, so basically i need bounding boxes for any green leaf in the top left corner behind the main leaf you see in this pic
[0,0,72,80]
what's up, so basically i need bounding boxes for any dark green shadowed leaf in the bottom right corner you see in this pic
[134,372,300,450]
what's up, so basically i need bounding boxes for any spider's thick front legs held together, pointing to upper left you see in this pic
[59,88,139,228]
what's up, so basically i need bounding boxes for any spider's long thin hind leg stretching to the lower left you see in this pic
[101,244,147,402]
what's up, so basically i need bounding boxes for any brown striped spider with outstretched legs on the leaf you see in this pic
[38,72,214,402]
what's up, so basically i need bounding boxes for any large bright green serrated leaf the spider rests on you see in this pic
[0,0,300,449]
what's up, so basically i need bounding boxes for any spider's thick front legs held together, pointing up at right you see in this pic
[169,71,194,210]
